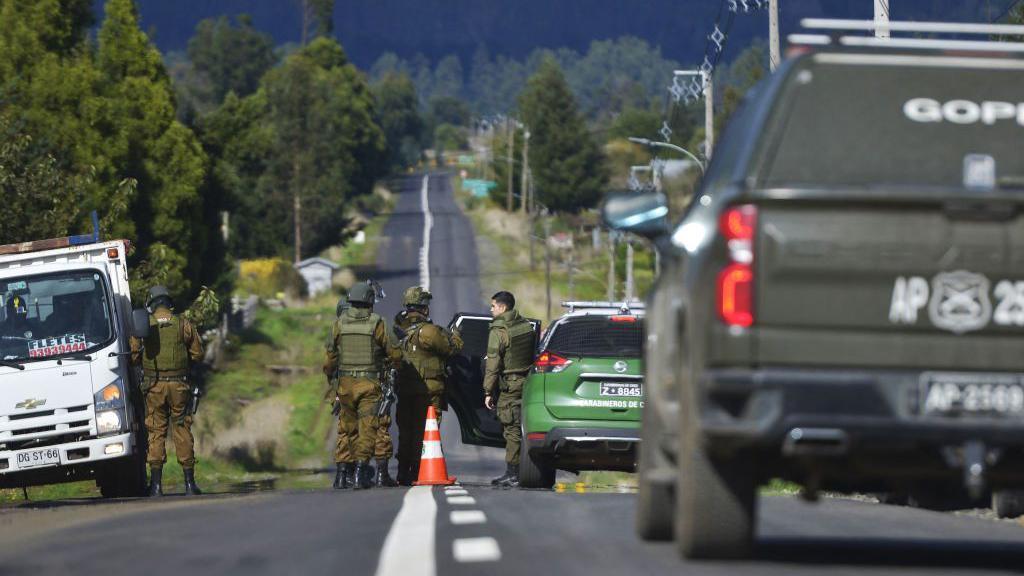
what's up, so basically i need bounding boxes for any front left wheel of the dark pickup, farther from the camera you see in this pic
[637,408,676,541]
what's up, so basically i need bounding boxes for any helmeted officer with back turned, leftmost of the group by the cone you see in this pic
[324,284,400,490]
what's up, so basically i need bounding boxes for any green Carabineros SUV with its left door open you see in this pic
[447,302,645,488]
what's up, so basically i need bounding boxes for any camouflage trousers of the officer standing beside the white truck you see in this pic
[145,380,196,468]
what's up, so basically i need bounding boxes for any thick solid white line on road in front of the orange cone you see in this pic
[377,486,437,576]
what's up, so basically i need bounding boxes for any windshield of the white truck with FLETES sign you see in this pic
[0,270,114,362]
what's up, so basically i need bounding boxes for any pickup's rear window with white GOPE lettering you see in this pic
[765,53,1024,188]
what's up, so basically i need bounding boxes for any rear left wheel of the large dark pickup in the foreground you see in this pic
[675,424,758,560]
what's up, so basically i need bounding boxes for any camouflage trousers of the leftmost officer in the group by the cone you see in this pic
[335,376,381,462]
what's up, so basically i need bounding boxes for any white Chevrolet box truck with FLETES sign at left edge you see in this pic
[0,233,147,497]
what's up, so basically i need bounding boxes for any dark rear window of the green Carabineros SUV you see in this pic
[546,316,644,358]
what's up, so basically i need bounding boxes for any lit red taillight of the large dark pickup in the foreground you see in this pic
[716,204,758,328]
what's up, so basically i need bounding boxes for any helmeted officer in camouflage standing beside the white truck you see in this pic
[131,286,203,496]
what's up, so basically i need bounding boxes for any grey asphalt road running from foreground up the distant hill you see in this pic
[0,171,1024,576]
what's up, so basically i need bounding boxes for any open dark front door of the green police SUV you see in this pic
[445,313,541,448]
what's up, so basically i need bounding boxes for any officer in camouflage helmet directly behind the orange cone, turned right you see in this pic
[394,286,462,486]
